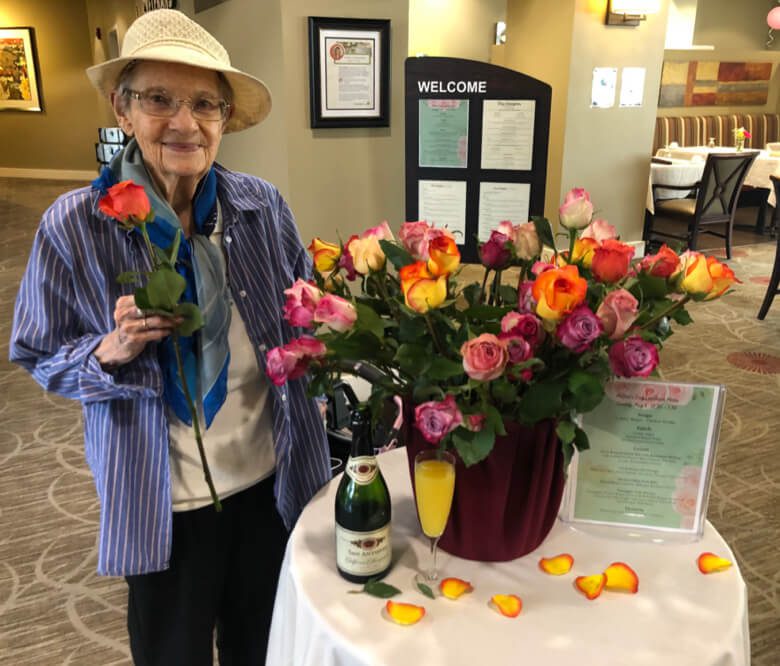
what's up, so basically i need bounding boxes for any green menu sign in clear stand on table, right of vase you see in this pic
[561,380,725,537]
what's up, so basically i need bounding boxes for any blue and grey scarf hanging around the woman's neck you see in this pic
[92,139,230,427]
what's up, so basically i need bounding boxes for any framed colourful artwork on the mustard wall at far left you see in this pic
[0,28,43,111]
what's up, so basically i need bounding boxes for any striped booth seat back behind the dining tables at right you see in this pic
[653,113,780,155]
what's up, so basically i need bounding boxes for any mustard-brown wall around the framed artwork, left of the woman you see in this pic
[0,0,99,172]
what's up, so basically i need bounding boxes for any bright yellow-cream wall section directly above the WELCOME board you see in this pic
[408,0,506,62]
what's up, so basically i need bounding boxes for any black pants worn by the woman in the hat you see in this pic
[126,477,287,666]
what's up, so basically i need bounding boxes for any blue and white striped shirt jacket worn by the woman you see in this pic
[10,165,330,576]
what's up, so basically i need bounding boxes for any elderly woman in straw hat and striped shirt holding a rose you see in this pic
[11,10,330,666]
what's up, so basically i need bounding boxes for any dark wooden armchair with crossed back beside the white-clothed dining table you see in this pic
[642,150,758,259]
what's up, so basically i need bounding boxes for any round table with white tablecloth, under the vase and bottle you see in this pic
[266,449,750,666]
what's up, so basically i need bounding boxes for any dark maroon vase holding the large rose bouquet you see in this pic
[406,421,564,562]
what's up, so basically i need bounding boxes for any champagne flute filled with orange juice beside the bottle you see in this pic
[414,449,455,587]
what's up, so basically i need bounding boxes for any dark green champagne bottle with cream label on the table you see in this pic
[336,408,392,583]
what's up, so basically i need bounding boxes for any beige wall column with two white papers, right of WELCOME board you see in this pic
[506,0,666,240]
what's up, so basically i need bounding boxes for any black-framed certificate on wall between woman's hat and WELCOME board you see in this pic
[309,16,390,127]
